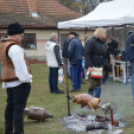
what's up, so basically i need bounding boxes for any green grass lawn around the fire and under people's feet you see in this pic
[0,64,134,134]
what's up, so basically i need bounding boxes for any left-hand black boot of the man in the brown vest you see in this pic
[5,120,13,134]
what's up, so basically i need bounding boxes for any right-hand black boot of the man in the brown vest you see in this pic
[14,122,24,134]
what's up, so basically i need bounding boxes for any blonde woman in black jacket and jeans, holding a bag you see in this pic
[85,28,108,98]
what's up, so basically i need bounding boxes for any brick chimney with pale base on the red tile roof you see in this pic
[28,0,38,17]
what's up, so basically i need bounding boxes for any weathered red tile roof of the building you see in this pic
[0,0,82,27]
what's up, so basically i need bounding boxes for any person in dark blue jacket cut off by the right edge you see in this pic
[125,32,134,100]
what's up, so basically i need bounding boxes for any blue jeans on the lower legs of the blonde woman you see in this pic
[88,86,101,98]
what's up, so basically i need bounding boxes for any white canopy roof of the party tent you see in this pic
[58,0,134,29]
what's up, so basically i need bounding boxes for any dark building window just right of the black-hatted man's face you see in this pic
[21,33,37,50]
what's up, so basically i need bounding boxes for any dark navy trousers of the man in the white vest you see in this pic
[49,67,59,92]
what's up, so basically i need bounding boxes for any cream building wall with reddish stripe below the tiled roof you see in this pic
[0,29,93,61]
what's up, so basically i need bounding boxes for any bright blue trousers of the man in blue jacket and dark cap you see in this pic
[70,61,82,89]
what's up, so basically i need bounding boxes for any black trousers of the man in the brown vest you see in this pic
[5,83,31,123]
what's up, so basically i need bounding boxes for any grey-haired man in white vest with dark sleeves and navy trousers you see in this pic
[45,33,64,94]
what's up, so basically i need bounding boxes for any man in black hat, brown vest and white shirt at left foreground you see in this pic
[0,23,32,134]
